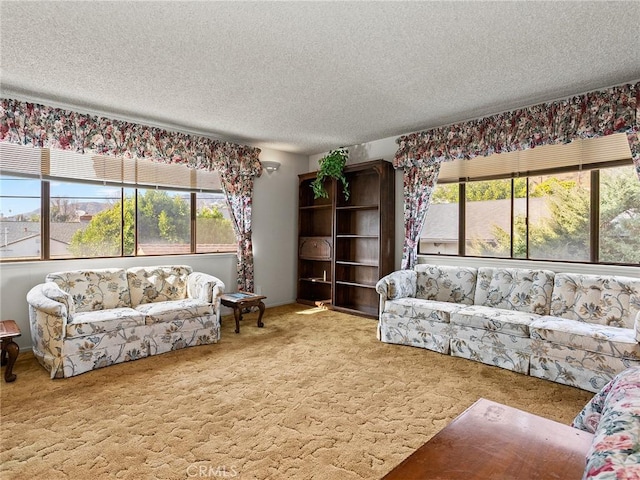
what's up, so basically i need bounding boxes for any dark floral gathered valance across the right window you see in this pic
[393,82,640,177]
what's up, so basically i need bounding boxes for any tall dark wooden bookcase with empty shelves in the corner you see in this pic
[298,160,395,317]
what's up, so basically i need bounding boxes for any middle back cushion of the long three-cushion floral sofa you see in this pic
[474,267,554,315]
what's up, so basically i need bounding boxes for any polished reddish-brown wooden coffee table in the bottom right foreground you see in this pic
[383,398,593,480]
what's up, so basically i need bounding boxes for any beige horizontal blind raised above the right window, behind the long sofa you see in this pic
[438,133,631,182]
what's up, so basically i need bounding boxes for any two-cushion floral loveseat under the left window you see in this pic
[27,265,224,378]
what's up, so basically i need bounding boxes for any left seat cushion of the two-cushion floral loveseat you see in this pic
[65,307,144,338]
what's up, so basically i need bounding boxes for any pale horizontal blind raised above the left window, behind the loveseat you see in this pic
[0,143,222,190]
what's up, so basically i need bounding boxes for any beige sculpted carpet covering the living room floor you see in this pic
[0,305,592,480]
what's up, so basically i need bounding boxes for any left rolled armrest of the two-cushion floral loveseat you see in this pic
[27,282,75,378]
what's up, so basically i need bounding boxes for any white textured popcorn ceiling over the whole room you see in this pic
[0,0,640,154]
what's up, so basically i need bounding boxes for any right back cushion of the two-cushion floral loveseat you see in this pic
[127,265,192,307]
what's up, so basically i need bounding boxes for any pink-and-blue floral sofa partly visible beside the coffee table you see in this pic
[571,367,640,480]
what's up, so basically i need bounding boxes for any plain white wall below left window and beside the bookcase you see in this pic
[0,149,308,351]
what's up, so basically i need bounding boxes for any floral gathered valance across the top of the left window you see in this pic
[0,99,262,176]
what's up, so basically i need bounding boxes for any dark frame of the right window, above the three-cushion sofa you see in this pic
[418,159,637,266]
